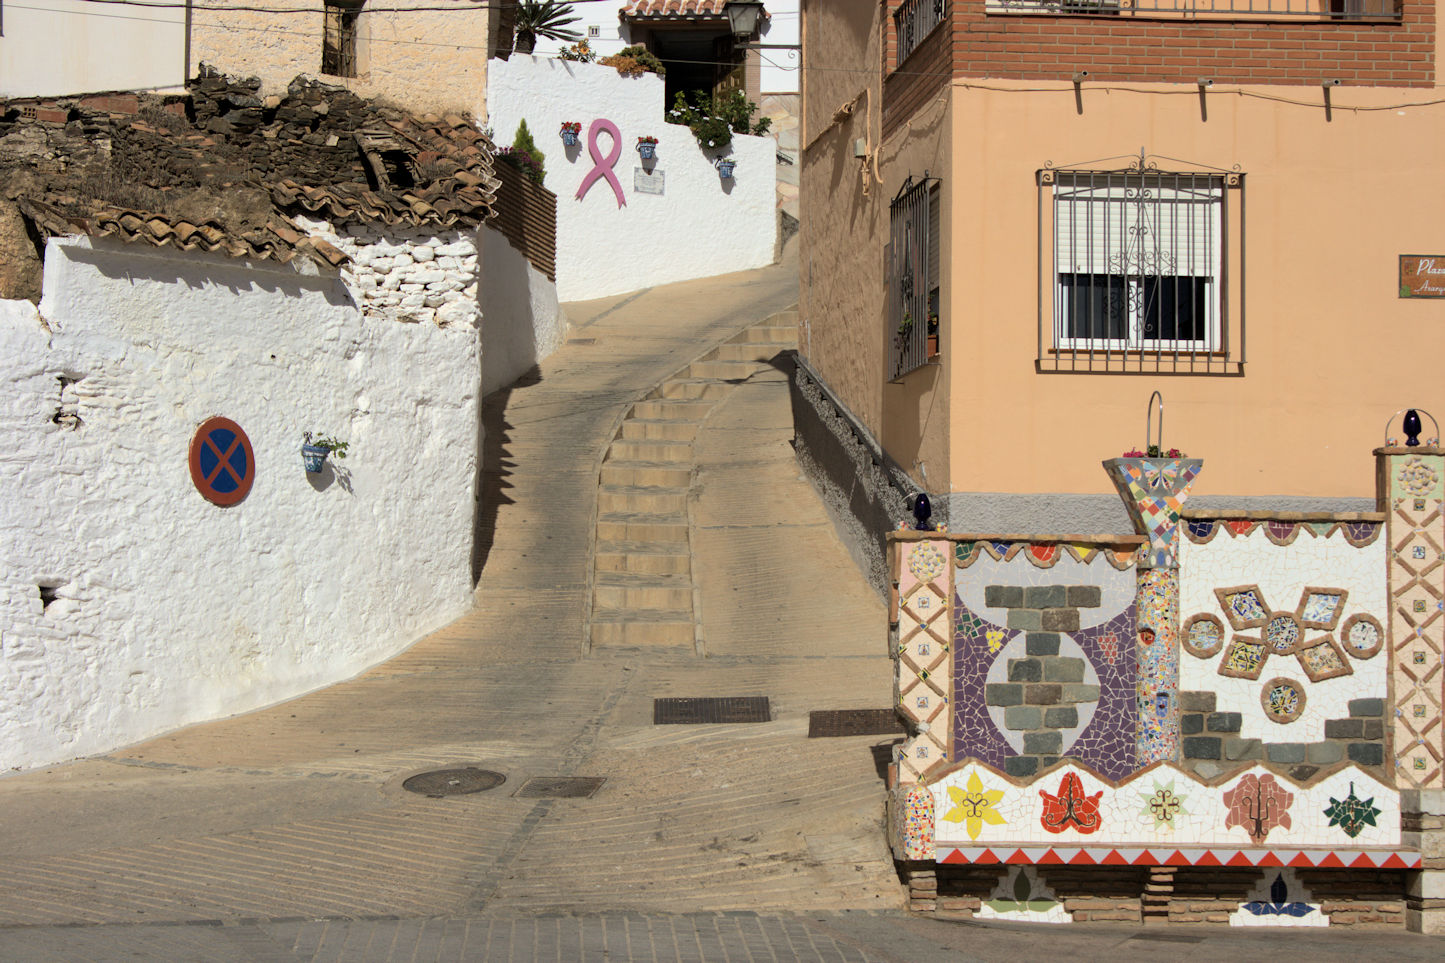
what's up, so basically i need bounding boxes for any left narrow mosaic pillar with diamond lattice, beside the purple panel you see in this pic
[892,539,952,782]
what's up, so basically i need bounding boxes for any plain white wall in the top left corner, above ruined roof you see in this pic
[0,0,186,97]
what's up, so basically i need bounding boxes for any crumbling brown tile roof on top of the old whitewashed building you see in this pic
[0,68,499,266]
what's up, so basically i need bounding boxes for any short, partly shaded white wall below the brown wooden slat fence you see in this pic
[477,227,566,398]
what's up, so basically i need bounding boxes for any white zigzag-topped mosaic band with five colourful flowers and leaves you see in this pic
[929,761,1400,850]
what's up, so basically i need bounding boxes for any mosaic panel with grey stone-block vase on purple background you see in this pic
[952,541,1137,776]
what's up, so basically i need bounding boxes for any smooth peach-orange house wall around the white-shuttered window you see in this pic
[942,81,1445,497]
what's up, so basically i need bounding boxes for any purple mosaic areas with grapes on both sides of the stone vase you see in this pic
[951,593,1139,779]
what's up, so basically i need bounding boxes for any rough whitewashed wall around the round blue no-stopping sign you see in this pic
[0,239,480,769]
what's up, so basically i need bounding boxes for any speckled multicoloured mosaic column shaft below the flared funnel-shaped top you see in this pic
[1134,568,1179,765]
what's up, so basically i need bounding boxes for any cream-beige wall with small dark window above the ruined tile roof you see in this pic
[189,0,493,116]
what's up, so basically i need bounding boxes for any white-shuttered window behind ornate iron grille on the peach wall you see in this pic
[1039,156,1243,373]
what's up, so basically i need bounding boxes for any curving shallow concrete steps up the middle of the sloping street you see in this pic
[588,311,798,655]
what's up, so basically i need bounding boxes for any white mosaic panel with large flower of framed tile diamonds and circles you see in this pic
[1179,518,1389,775]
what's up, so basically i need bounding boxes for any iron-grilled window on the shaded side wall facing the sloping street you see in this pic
[889,175,942,379]
